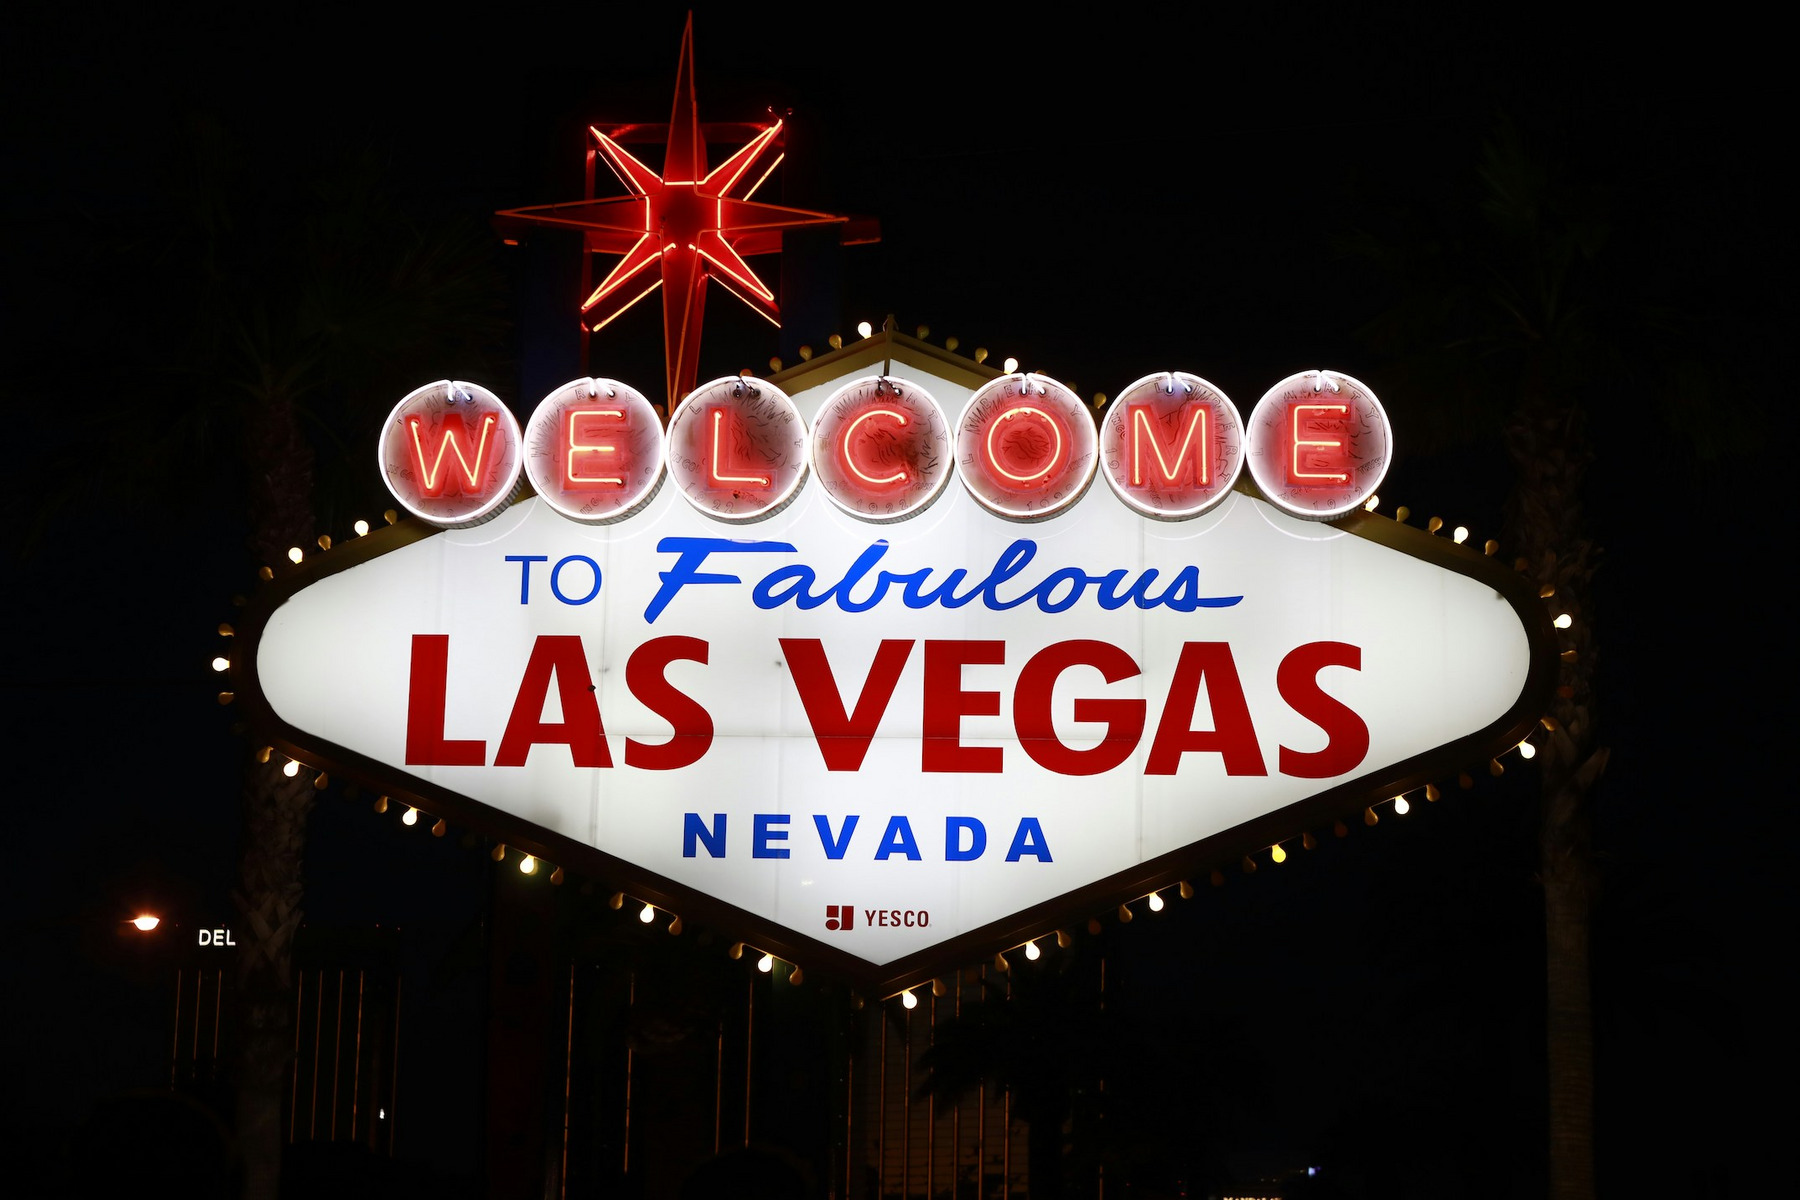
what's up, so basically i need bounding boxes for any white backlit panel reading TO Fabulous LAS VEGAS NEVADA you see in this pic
[256,352,1555,981]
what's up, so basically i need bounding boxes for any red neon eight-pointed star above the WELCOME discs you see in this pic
[499,14,867,405]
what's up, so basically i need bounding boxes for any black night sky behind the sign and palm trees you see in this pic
[0,4,1793,1196]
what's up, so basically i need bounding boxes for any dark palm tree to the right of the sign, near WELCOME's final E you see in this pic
[1346,122,1735,1200]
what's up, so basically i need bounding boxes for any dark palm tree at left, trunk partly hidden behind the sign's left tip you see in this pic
[59,119,511,1198]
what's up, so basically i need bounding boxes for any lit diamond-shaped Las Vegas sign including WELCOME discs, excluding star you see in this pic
[234,335,1555,988]
